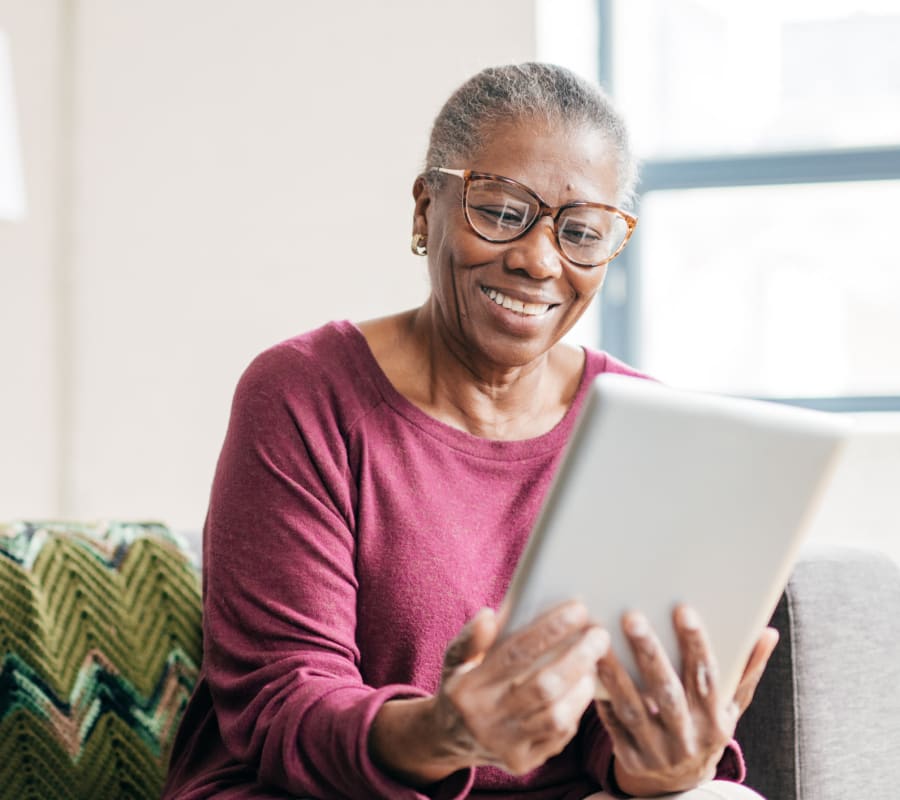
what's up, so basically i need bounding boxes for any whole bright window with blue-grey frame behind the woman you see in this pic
[598,0,900,410]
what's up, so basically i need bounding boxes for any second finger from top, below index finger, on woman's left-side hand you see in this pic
[509,626,609,711]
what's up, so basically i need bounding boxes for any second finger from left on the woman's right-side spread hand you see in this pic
[616,612,689,732]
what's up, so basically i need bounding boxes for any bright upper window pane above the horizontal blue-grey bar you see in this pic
[612,0,900,158]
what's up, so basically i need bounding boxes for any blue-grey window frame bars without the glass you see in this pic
[597,0,900,412]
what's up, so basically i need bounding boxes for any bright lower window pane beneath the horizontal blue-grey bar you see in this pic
[633,181,900,397]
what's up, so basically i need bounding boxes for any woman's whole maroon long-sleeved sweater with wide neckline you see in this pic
[164,322,743,800]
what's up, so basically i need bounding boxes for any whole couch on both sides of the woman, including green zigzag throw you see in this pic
[0,523,900,800]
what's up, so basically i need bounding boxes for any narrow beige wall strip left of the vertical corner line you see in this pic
[0,0,64,519]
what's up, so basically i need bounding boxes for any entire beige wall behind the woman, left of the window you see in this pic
[0,0,535,528]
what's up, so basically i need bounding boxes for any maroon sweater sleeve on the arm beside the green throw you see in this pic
[204,347,473,800]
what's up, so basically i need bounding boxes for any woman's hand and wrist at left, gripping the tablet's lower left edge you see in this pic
[370,602,609,784]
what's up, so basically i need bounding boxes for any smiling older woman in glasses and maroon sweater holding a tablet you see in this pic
[165,64,774,800]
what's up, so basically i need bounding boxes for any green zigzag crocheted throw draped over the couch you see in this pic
[0,522,201,800]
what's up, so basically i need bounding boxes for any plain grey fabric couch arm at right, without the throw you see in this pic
[738,547,900,800]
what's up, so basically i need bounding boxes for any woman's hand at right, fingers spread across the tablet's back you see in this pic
[596,606,778,797]
